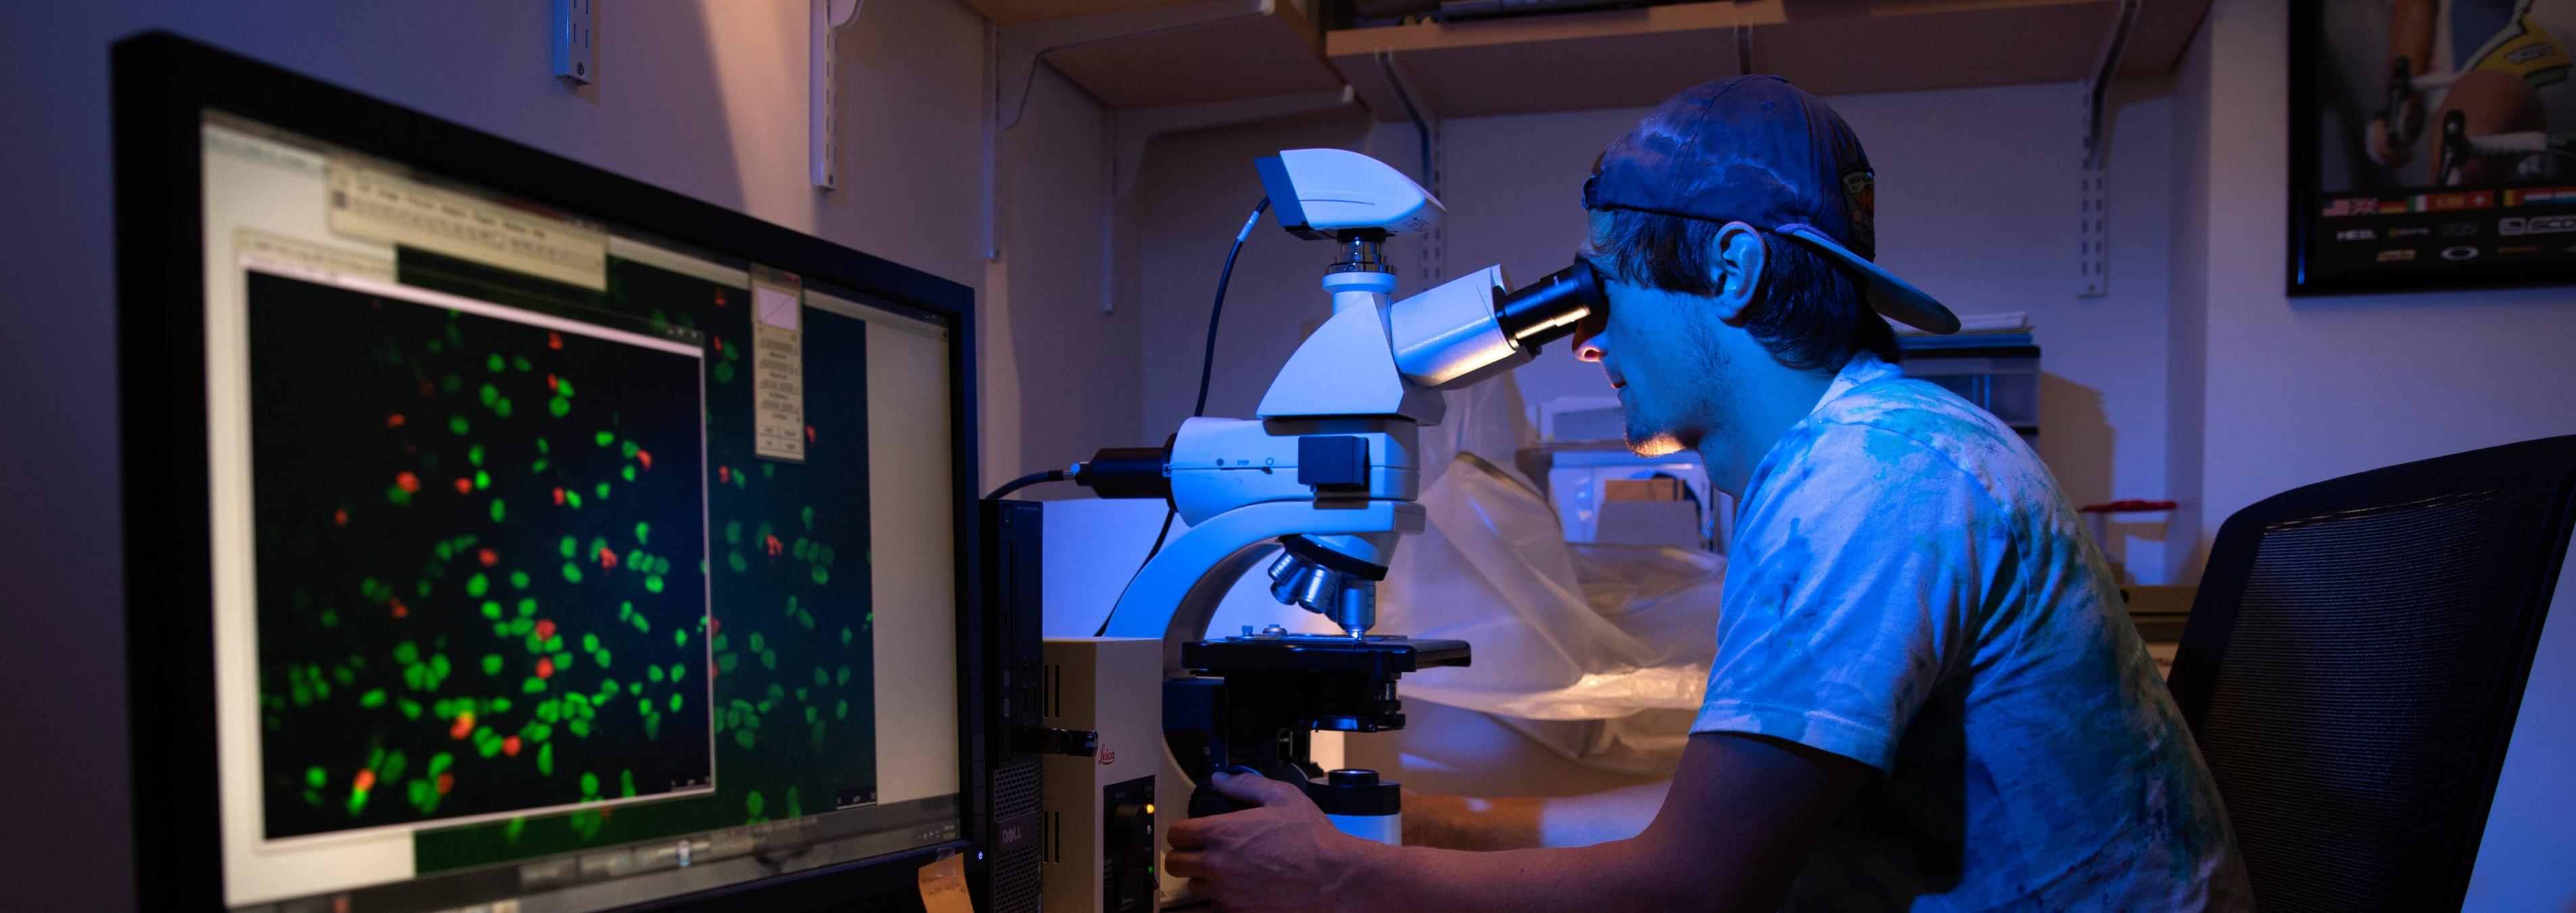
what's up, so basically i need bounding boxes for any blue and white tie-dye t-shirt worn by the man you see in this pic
[1693,352,2252,910]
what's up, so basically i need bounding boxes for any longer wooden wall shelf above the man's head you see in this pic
[1324,0,2210,121]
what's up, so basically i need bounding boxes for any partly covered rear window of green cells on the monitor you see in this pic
[397,249,881,872]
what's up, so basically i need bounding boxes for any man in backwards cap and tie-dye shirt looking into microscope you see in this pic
[1167,77,2246,910]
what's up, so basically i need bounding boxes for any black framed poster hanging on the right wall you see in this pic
[2290,0,2576,296]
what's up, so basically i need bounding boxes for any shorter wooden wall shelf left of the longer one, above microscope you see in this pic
[966,0,1342,112]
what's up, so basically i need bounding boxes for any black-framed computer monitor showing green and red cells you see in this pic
[114,36,981,913]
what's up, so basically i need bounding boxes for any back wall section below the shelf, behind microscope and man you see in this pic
[1136,82,2172,584]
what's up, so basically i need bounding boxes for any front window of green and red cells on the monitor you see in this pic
[245,272,721,839]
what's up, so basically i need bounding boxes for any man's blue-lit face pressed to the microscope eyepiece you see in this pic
[1574,260,1731,455]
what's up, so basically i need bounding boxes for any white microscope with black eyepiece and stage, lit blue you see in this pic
[1071,149,1605,910]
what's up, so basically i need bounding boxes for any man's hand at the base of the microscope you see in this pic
[1162,774,1378,913]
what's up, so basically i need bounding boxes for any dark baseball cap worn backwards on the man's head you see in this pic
[1584,77,1958,332]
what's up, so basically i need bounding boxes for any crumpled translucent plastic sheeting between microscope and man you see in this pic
[1378,383,1726,774]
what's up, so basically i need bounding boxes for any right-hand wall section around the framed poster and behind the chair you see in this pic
[2172,0,2576,910]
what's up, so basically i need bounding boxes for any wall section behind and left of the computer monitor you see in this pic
[0,0,1128,910]
